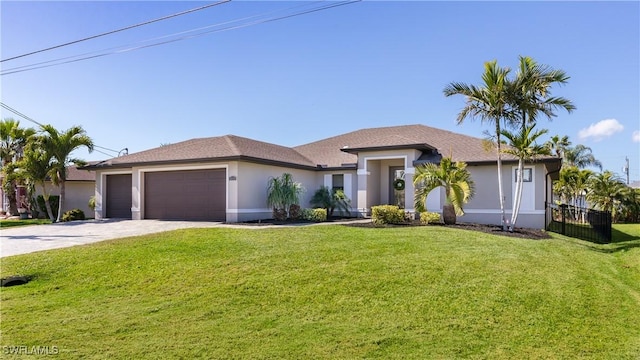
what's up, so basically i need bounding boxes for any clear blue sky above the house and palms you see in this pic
[0,1,640,181]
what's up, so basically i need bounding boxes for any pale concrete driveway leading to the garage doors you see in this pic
[0,220,221,257]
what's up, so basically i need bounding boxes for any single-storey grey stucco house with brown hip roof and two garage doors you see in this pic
[86,125,561,228]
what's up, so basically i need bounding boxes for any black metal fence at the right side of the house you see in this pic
[545,204,611,244]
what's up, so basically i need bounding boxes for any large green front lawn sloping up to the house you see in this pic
[0,225,640,359]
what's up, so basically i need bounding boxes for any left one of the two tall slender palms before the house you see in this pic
[444,60,515,230]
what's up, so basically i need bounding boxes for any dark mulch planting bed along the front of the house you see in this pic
[235,218,551,240]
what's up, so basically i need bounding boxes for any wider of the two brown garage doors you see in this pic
[144,169,227,221]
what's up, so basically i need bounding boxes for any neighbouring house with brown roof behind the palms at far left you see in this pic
[0,166,96,217]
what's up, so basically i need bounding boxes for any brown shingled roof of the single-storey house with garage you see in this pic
[88,125,557,168]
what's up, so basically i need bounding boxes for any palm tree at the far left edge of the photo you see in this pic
[0,118,35,215]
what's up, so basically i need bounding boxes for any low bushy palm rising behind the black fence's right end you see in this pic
[587,170,627,219]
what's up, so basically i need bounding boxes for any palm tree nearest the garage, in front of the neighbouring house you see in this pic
[40,125,93,221]
